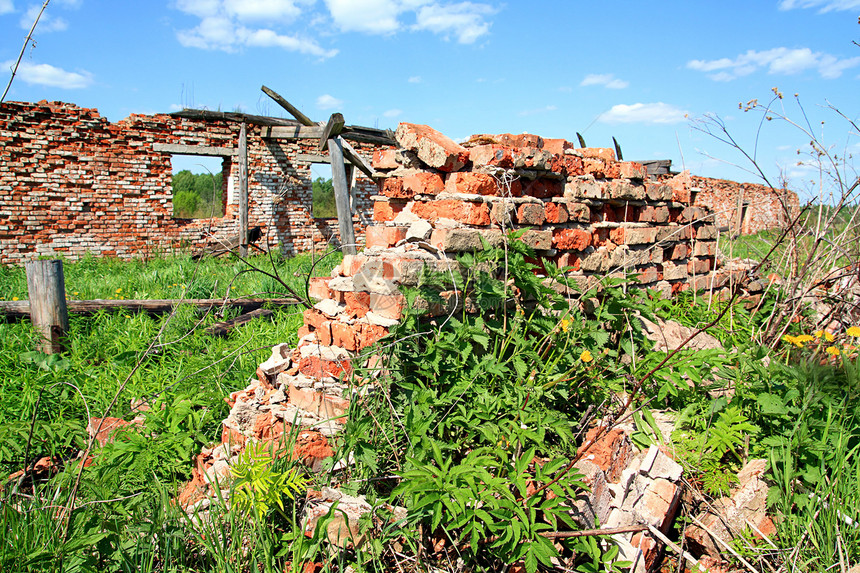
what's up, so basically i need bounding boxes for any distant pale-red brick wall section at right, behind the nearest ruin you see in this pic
[690,176,800,235]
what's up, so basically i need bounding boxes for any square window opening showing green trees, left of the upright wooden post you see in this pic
[170,154,231,219]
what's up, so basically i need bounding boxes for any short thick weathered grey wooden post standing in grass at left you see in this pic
[24,260,69,354]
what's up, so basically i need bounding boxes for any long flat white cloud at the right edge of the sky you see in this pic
[687,48,860,81]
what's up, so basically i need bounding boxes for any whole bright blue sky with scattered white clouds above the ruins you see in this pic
[0,0,860,197]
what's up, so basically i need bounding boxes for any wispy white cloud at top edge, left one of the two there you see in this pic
[176,0,338,58]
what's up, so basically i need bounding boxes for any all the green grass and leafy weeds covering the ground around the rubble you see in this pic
[0,249,860,573]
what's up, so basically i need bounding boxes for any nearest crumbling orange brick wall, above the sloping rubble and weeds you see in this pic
[356,124,716,294]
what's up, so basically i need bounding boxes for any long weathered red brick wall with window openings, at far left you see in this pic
[0,101,376,264]
